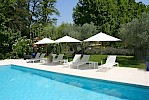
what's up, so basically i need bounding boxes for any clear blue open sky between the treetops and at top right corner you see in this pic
[56,0,149,26]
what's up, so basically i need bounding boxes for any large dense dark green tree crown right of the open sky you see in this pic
[73,0,148,36]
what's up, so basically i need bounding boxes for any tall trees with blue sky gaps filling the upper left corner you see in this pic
[0,0,59,55]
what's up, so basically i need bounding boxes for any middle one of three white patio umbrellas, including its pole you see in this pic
[55,36,81,59]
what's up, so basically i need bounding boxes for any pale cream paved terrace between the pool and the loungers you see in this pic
[0,59,149,86]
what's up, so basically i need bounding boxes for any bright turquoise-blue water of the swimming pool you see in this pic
[0,65,149,100]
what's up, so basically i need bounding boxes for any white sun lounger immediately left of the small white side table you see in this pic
[71,55,90,68]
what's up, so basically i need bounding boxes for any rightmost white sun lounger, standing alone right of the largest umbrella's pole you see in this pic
[98,55,119,70]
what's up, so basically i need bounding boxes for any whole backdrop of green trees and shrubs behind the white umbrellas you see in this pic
[0,0,149,60]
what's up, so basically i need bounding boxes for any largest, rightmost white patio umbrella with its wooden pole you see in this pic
[84,32,121,64]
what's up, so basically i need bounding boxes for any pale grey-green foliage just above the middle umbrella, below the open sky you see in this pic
[54,23,98,40]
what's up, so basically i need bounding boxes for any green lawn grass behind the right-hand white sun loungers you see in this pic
[90,55,145,69]
